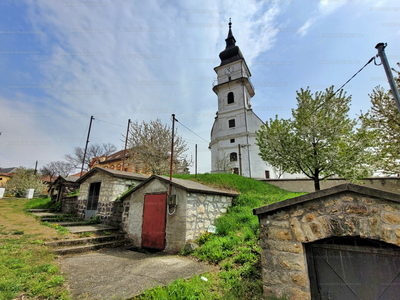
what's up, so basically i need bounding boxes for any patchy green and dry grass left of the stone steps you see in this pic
[0,199,70,300]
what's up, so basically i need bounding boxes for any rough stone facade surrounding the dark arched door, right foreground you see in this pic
[259,192,400,300]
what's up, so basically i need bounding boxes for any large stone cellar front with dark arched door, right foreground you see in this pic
[254,184,400,300]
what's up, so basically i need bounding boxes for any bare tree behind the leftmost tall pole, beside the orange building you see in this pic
[65,143,117,171]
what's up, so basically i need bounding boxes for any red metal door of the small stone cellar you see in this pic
[142,194,167,250]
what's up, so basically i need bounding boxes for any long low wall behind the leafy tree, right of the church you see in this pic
[262,177,400,194]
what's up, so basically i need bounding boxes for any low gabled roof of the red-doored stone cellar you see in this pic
[121,175,239,199]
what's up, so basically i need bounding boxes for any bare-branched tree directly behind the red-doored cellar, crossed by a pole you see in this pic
[128,119,193,175]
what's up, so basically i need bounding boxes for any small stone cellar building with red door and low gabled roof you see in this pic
[120,175,238,252]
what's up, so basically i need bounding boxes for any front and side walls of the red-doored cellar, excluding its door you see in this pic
[122,180,236,253]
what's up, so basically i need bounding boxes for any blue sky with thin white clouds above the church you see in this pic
[0,0,400,173]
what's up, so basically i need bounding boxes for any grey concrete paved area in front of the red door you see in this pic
[59,249,213,299]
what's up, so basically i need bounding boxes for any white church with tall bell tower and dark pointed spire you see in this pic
[210,21,277,178]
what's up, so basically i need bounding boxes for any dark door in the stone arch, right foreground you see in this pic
[306,244,400,300]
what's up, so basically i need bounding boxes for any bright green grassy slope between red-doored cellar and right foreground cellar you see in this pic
[134,174,304,300]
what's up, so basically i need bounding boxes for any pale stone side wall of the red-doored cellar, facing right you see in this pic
[186,193,232,242]
